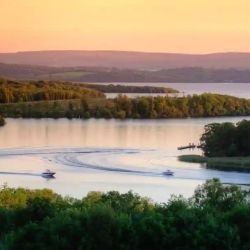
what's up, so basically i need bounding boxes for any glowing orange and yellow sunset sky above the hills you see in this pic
[0,0,250,53]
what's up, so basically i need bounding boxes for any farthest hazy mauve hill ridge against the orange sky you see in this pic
[0,51,250,70]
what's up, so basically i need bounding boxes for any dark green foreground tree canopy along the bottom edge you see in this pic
[0,180,250,250]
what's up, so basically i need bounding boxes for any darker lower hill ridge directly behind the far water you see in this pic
[0,63,250,83]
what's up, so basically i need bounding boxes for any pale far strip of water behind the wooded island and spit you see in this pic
[101,83,250,99]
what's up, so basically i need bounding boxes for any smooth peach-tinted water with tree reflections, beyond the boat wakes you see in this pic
[0,117,247,149]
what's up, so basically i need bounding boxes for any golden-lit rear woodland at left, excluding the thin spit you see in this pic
[0,79,104,103]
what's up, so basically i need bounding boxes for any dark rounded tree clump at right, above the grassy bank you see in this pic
[201,120,250,157]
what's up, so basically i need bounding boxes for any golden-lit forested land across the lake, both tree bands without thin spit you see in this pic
[0,80,250,119]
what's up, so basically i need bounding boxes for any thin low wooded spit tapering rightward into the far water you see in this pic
[81,83,179,93]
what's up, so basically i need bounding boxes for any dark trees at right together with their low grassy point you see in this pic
[179,120,250,172]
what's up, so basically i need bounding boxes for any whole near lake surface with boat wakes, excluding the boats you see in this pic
[0,117,250,201]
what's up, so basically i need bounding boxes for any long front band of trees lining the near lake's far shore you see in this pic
[0,94,250,119]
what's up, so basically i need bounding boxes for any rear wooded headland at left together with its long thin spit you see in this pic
[0,79,178,103]
